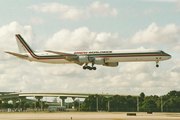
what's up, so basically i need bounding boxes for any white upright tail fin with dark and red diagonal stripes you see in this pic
[15,34,33,53]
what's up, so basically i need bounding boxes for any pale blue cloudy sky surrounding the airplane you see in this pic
[0,0,180,100]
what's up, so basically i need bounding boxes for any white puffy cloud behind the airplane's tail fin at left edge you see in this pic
[0,21,35,58]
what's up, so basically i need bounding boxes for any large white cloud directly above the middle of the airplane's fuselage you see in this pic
[44,27,118,50]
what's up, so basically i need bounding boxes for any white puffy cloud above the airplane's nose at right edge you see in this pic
[130,23,180,44]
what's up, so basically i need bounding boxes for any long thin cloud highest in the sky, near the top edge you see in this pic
[28,1,117,21]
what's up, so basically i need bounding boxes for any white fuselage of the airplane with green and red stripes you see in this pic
[23,49,171,64]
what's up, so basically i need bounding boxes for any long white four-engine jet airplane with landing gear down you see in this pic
[5,34,171,70]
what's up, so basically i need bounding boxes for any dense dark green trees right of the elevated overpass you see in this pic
[74,90,180,112]
